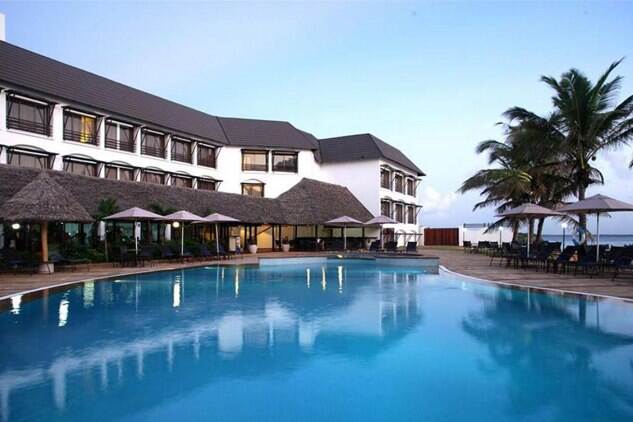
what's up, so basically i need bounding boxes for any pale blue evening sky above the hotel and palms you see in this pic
[0,1,633,234]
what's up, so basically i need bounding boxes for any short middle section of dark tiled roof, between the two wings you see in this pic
[218,117,318,150]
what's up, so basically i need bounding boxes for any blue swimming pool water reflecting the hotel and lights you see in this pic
[0,261,633,422]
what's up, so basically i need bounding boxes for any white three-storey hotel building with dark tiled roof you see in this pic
[0,41,424,243]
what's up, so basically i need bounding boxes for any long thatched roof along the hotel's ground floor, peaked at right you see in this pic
[0,165,372,225]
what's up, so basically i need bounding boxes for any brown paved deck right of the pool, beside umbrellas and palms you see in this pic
[422,247,633,300]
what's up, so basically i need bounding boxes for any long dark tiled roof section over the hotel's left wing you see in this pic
[0,41,226,143]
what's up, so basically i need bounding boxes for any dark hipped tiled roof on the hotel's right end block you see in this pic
[319,133,425,176]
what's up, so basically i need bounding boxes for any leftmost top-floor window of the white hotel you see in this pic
[7,94,53,136]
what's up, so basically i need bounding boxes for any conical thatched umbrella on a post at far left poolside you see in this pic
[0,172,93,272]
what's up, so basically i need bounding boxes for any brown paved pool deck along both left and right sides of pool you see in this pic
[0,247,633,300]
